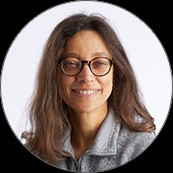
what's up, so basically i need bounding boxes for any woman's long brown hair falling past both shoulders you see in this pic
[22,13,155,163]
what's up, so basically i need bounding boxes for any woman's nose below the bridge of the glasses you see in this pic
[76,64,94,83]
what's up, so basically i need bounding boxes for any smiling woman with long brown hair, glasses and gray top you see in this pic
[22,14,155,172]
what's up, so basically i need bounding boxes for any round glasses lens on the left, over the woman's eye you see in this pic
[61,57,81,75]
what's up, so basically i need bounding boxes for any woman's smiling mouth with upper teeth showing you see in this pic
[72,89,100,96]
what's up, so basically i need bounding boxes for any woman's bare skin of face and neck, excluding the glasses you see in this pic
[59,31,113,160]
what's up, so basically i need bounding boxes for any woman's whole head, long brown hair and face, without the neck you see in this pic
[23,14,155,162]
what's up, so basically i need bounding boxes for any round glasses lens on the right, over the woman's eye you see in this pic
[91,57,111,76]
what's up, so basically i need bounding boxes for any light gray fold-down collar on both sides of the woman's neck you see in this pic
[63,109,120,156]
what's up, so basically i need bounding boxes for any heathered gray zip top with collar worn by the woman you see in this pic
[55,111,155,173]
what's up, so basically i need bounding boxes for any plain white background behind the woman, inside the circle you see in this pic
[1,1,172,141]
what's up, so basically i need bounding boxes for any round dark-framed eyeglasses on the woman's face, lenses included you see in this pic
[59,57,113,77]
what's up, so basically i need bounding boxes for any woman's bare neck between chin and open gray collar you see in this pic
[70,105,108,158]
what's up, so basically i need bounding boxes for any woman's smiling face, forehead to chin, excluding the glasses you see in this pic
[59,31,113,113]
